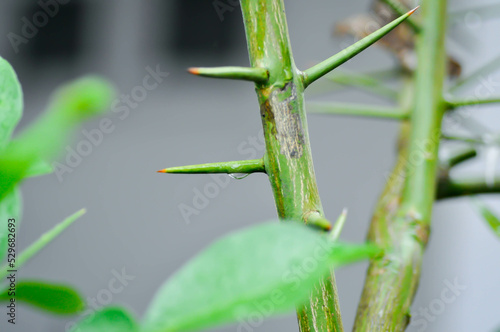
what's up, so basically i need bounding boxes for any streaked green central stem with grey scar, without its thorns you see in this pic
[241,0,343,332]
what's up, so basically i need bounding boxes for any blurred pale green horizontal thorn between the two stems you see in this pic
[307,103,410,120]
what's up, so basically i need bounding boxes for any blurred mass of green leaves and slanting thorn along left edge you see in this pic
[0,58,114,314]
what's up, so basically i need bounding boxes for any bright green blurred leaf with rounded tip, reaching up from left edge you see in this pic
[0,77,114,199]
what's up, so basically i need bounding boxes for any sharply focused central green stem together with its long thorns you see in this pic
[164,0,418,332]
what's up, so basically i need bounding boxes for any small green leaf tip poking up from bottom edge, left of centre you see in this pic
[70,307,139,332]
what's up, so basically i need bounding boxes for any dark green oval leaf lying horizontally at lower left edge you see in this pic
[0,281,85,315]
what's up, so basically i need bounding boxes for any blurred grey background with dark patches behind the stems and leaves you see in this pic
[0,0,500,332]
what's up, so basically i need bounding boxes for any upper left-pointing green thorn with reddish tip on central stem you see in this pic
[188,67,269,83]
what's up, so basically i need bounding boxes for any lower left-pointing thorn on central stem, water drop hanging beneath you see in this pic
[158,159,266,174]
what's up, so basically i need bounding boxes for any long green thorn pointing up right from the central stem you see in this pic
[303,7,418,87]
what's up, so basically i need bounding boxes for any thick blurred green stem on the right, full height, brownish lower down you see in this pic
[354,0,446,331]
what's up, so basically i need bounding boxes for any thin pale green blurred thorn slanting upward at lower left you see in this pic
[0,209,86,279]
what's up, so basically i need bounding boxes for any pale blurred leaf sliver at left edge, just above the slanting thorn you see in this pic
[0,187,22,262]
